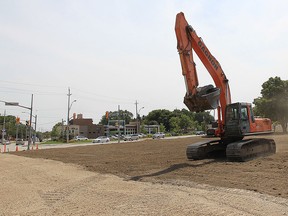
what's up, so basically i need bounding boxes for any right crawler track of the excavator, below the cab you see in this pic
[226,138,276,161]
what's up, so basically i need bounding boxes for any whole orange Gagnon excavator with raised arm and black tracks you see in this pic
[175,12,276,161]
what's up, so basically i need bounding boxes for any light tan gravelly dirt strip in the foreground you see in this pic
[0,154,288,216]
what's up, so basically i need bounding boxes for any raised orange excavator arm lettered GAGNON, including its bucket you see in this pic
[175,12,231,125]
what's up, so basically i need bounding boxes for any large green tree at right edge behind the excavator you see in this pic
[253,76,288,133]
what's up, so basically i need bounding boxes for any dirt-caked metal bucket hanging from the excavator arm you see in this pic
[184,85,220,112]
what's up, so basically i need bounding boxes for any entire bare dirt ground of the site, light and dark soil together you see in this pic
[0,135,288,215]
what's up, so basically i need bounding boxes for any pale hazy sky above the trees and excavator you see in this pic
[0,0,288,131]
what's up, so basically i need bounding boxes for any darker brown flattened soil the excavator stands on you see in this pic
[13,135,288,198]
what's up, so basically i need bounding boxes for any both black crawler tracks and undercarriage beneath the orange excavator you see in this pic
[186,138,276,161]
